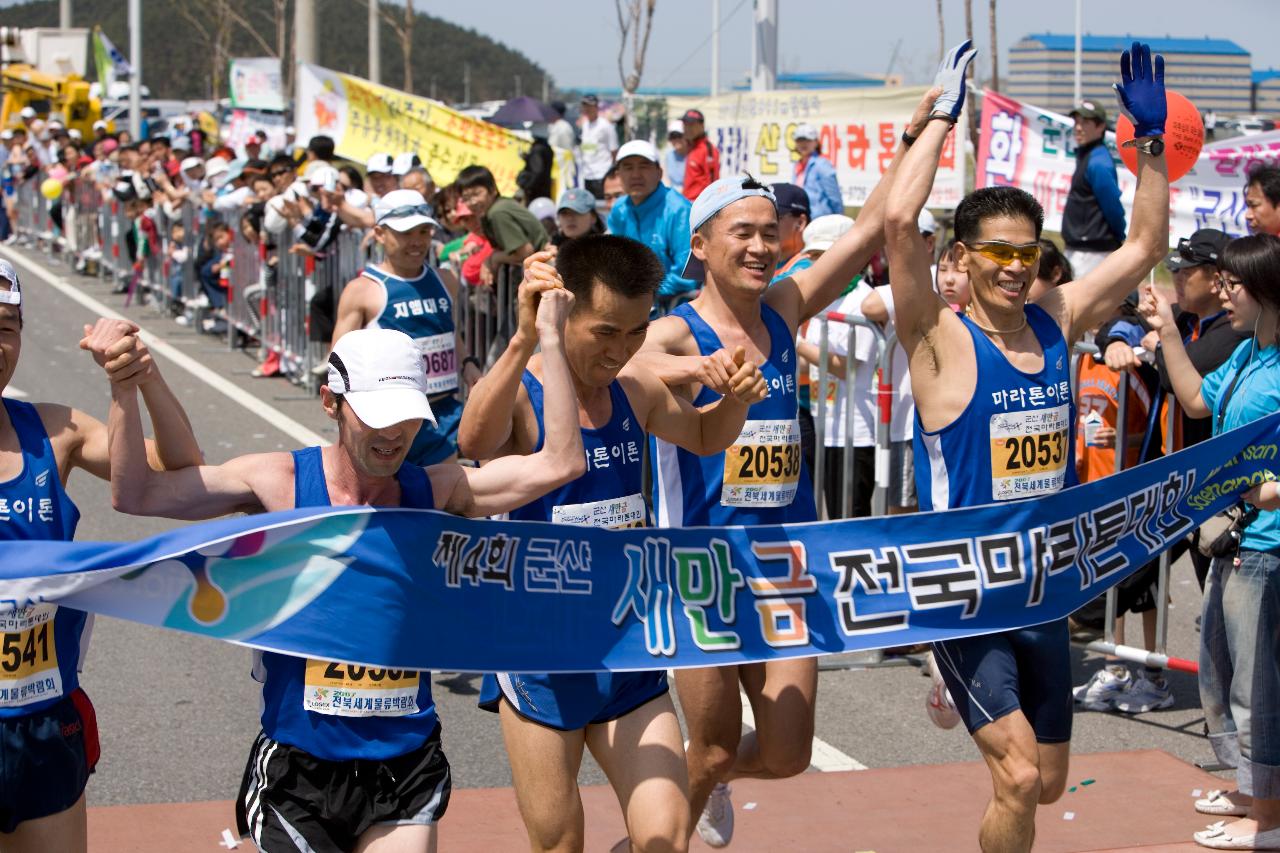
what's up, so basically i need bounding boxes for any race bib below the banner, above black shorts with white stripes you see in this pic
[302,657,420,717]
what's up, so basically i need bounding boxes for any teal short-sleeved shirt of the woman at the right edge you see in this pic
[1201,338,1280,553]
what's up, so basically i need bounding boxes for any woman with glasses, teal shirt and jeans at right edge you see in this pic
[1140,234,1280,850]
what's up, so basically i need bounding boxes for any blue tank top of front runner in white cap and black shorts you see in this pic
[253,447,436,761]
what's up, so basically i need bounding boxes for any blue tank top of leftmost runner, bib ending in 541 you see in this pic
[0,400,88,717]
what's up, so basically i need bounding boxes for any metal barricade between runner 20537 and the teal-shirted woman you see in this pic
[1071,341,1199,672]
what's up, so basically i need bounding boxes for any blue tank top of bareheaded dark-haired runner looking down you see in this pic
[508,370,648,528]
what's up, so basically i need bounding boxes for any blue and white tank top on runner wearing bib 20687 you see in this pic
[361,265,458,396]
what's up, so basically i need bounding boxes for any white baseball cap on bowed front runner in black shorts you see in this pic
[329,329,435,429]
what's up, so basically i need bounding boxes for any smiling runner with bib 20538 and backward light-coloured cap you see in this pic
[636,84,933,847]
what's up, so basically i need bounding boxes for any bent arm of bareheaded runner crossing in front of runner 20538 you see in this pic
[618,347,769,456]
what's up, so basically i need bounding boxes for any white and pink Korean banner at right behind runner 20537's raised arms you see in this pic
[975,91,1280,240]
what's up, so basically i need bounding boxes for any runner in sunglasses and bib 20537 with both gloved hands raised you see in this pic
[884,42,1169,850]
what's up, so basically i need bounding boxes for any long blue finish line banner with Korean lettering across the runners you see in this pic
[0,415,1280,671]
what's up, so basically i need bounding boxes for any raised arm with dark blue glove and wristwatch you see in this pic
[1038,42,1169,341]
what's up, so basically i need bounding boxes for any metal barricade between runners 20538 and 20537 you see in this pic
[810,311,893,519]
